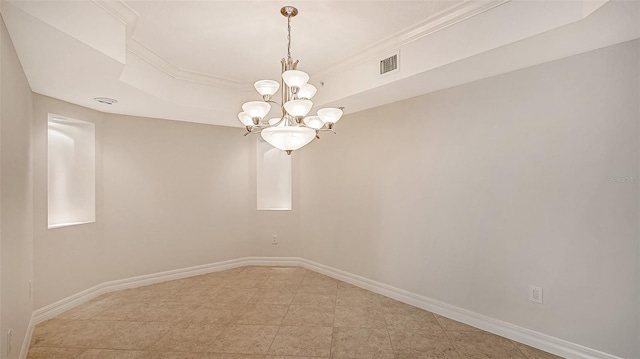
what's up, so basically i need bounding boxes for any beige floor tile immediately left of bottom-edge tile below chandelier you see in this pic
[211,325,278,354]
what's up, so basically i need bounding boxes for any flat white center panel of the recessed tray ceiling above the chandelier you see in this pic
[127,0,461,83]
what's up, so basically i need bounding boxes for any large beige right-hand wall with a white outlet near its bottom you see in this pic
[299,41,640,358]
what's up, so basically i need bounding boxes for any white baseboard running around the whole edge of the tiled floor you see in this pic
[20,257,622,359]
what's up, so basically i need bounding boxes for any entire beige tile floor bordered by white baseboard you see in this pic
[28,267,558,359]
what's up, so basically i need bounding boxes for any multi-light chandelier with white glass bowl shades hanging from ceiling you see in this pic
[238,6,343,155]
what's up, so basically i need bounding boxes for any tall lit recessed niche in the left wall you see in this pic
[47,114,96,228]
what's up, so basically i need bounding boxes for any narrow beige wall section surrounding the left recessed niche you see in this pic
[32,94,105,308]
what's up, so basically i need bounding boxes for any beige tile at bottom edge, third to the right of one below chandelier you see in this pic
[447,331,527,359]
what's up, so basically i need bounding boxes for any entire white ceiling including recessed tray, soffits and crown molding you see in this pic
[0,0,640,126]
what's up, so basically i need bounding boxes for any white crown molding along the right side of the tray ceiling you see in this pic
[313,0,511,80]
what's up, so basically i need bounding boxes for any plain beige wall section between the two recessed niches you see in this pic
[103,115,255,280]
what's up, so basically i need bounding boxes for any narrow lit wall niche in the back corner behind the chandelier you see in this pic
[256,140,291,211]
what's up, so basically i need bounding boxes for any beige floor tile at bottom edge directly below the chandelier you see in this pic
[269,326,333,357]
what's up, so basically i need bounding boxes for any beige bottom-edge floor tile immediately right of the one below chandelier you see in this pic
[331,328,394,359]
